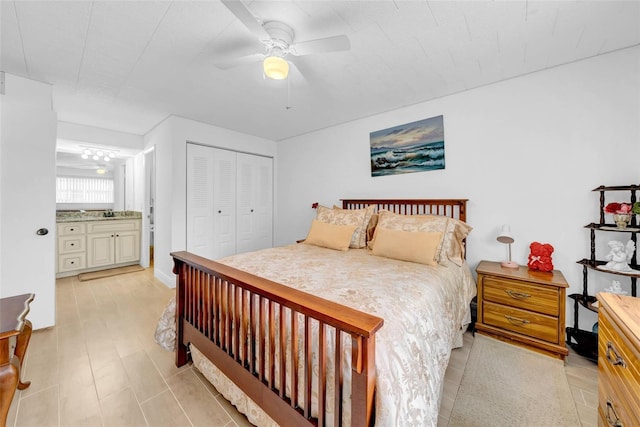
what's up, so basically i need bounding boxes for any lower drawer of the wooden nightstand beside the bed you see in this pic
[482,301,559,344]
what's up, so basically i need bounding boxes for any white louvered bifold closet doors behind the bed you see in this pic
[187,144,273,259]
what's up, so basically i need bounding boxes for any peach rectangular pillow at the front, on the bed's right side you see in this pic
[372,228,442,265]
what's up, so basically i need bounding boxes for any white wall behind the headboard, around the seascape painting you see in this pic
[276,46,640,328]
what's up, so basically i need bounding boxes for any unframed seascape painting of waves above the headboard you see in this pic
[369,116,444,176]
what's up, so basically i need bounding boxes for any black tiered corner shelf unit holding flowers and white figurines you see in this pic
[566,185,640,362]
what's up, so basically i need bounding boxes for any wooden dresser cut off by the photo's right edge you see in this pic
[597,292,640,426]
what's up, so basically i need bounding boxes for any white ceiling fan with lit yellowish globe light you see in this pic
[216,0,351,80]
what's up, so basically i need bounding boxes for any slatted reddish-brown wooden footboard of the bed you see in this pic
[171,252,383,426]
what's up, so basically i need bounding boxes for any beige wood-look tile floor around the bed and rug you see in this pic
[7,269,598,427]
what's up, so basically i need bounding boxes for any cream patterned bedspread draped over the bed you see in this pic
[158,244,476,426]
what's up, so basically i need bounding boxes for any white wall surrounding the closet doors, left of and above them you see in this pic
[145,116,276,287]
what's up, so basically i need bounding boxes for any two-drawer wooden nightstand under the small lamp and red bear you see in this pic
[475,261,569,360]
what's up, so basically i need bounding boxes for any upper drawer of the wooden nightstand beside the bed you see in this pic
[482,277,559,316]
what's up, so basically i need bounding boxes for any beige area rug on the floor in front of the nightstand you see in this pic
[449,334,580,427]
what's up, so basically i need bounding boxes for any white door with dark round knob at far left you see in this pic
[0,74,56,329]
